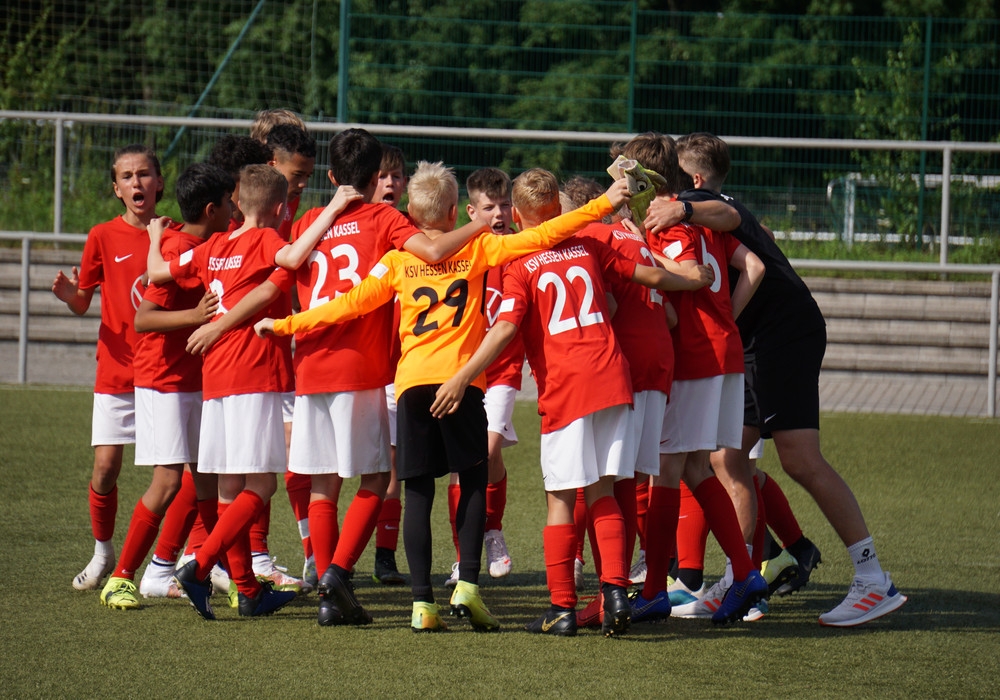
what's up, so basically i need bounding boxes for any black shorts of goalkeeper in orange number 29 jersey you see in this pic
[396,384,489,481]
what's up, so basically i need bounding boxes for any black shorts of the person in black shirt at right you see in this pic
[744,329,826,438]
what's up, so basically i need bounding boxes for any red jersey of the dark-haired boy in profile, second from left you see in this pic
[135,227,205,393]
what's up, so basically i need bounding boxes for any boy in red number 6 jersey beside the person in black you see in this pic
[641,146,767,624]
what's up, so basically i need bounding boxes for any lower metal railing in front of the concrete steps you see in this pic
[0,231,1000,418]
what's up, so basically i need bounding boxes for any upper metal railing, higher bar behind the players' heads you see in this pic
[0,110,1000,265]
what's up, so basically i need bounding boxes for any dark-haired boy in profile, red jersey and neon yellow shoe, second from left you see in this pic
[101,163,235,610]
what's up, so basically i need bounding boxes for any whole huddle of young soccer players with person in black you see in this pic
[53,110,906,636]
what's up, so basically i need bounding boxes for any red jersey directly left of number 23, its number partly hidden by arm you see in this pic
[170,228,293,400]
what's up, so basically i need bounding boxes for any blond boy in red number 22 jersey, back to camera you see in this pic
[431,168,711,636]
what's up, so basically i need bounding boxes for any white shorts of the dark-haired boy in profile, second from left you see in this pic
[135,387,201,466]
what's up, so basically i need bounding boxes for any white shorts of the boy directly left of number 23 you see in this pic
[198,392,285,474]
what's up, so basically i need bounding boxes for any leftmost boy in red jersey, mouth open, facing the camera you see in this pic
[52,144,163,591]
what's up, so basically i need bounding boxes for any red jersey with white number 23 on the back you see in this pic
[286,203,418,394]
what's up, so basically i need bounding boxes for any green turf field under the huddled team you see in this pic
[0,387,1000,698]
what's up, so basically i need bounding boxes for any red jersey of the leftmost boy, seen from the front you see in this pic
[79,216,149,394]
